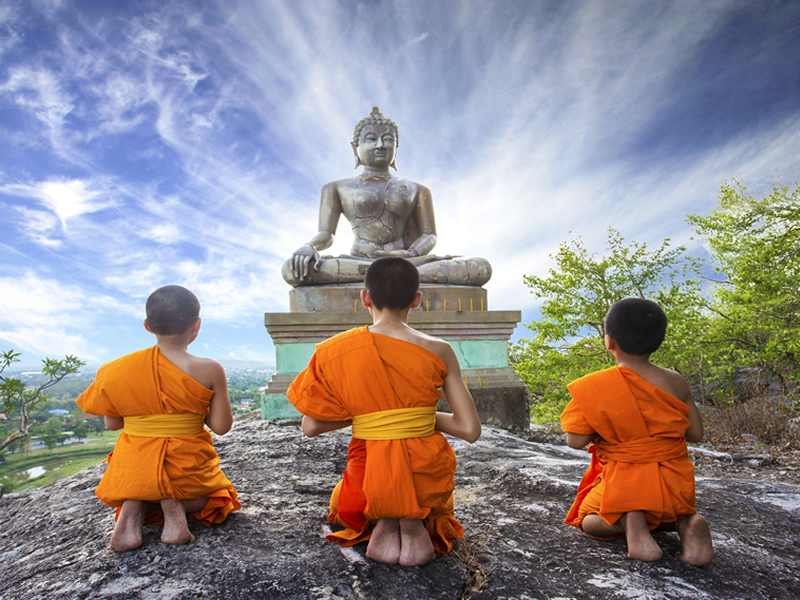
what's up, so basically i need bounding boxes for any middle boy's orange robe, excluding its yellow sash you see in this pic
[287,327,464,554]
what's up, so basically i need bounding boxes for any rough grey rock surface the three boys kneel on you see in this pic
[0,413,800,600]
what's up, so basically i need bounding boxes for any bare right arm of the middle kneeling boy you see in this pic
[436,342,481,444]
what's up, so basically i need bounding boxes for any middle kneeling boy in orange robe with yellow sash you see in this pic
[288,257,481,566]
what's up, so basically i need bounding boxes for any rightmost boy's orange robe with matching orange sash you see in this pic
[561,367,696,530]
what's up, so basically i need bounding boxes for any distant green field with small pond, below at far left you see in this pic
[0,430,122,493]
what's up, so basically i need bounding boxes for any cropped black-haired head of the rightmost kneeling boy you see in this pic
[605,298,667,356]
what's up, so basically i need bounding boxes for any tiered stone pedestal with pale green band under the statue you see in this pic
[261,284,530,430]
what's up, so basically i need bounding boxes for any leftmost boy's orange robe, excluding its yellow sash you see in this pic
[76,346,241,525]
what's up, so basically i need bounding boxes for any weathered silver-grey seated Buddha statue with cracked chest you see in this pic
[282,107,492,287]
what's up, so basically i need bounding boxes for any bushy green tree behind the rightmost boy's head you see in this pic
[510,228,708,422]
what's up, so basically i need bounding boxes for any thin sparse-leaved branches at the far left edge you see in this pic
[0,350,85,450]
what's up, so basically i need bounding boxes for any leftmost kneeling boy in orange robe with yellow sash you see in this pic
[77,285,241,552]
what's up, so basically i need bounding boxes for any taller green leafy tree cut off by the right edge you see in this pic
[687,179,800,382]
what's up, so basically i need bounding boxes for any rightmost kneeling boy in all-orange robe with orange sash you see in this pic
[561,298,714,566]
